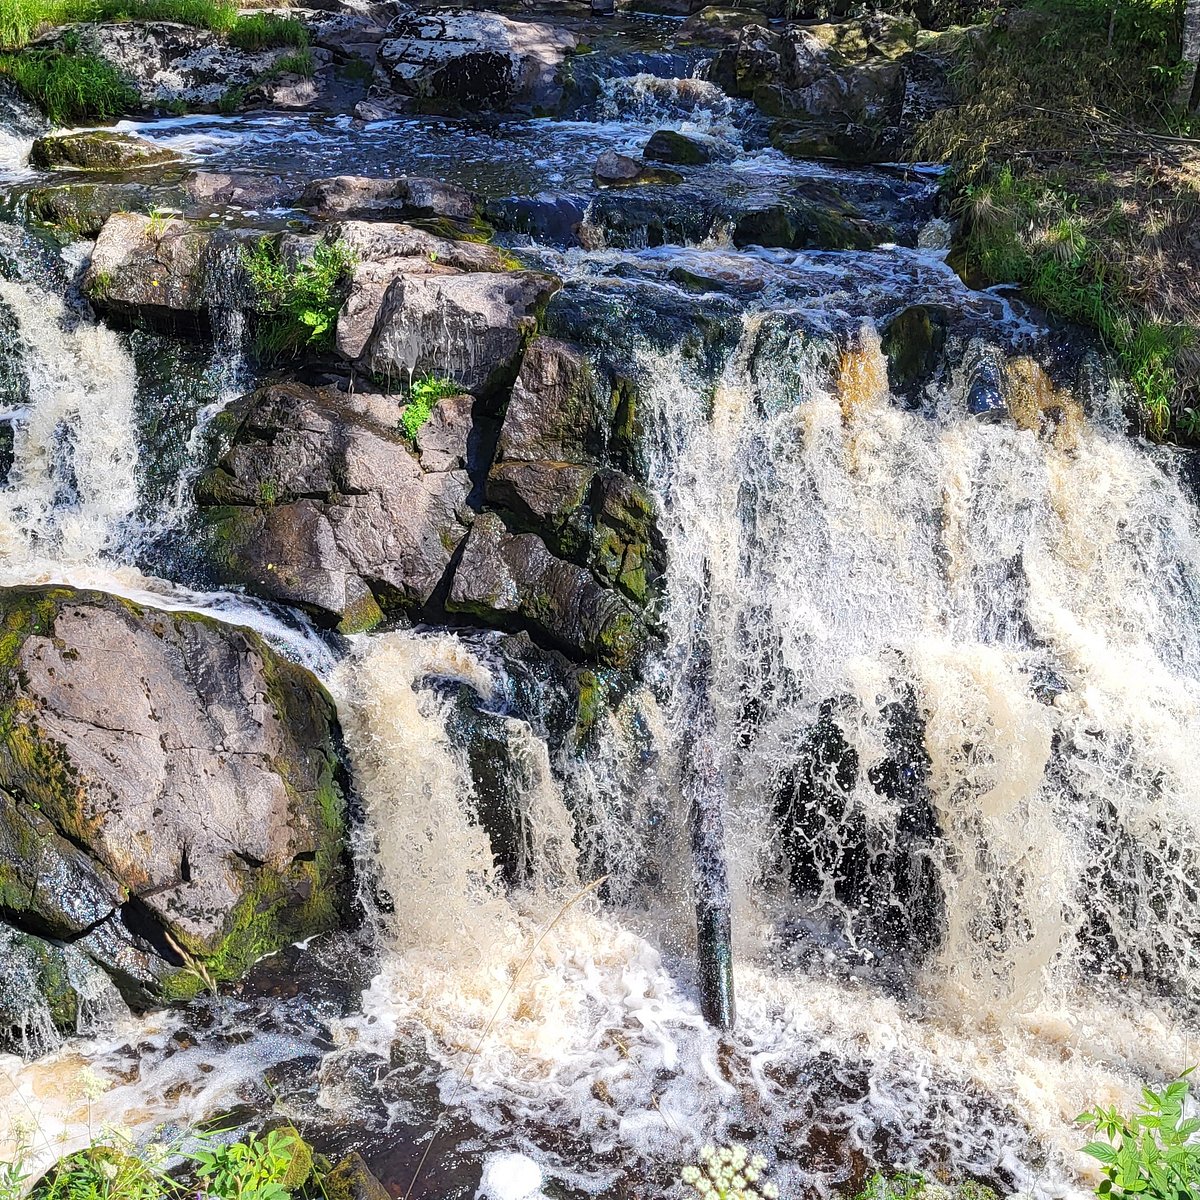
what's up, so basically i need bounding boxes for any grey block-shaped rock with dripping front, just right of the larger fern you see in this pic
[355,271,560,395]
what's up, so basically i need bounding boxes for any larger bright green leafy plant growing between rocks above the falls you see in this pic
[241,238,358,356]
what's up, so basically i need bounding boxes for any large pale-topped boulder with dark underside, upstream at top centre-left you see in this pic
[379,8,577,112]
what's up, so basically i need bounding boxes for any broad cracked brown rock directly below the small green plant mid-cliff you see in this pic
[197,384,474,632]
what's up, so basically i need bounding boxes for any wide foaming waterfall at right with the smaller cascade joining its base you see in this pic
[324,316,1200,1196]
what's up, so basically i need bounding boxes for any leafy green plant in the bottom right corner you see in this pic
[1076,1068,1200,1200]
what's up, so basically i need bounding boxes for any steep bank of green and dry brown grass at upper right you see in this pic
[914,0,1200,439]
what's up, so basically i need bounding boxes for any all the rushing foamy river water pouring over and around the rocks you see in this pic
[0,21,1200,1198]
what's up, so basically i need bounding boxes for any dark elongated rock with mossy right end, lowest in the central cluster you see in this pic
[446,512,641,666]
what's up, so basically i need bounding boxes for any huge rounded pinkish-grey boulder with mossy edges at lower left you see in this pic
[0,588,346,1004]
